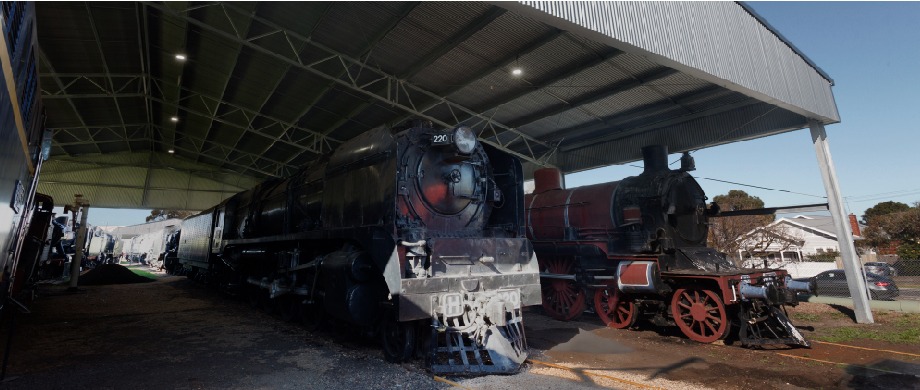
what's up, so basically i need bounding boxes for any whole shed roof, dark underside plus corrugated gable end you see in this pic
[36,2,839,210]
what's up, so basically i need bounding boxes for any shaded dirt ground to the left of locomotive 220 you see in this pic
[0,277,449,389]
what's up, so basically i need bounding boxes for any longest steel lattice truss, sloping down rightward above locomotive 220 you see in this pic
[150,3,553,165]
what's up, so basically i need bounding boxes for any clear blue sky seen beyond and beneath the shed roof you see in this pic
[77,2,920,226]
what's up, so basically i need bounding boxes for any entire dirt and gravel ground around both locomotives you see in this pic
[0,276,920,389]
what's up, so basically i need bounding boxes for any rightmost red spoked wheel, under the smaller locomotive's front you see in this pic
[671,287,729,343]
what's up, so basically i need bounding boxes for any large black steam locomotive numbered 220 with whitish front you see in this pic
[178,122,540,373]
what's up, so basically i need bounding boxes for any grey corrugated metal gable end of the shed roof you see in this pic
[492,1,840,124]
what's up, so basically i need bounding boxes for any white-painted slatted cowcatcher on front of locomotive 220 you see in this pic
[427,291,527,374]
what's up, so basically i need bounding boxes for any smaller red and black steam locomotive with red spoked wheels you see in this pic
[525,146,809,347]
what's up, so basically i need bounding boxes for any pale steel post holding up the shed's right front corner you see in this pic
[808,120,875,324]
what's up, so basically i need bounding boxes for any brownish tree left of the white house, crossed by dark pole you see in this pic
[708,190,775,257]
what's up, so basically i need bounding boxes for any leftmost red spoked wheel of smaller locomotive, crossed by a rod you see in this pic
[541,259,587,321]
